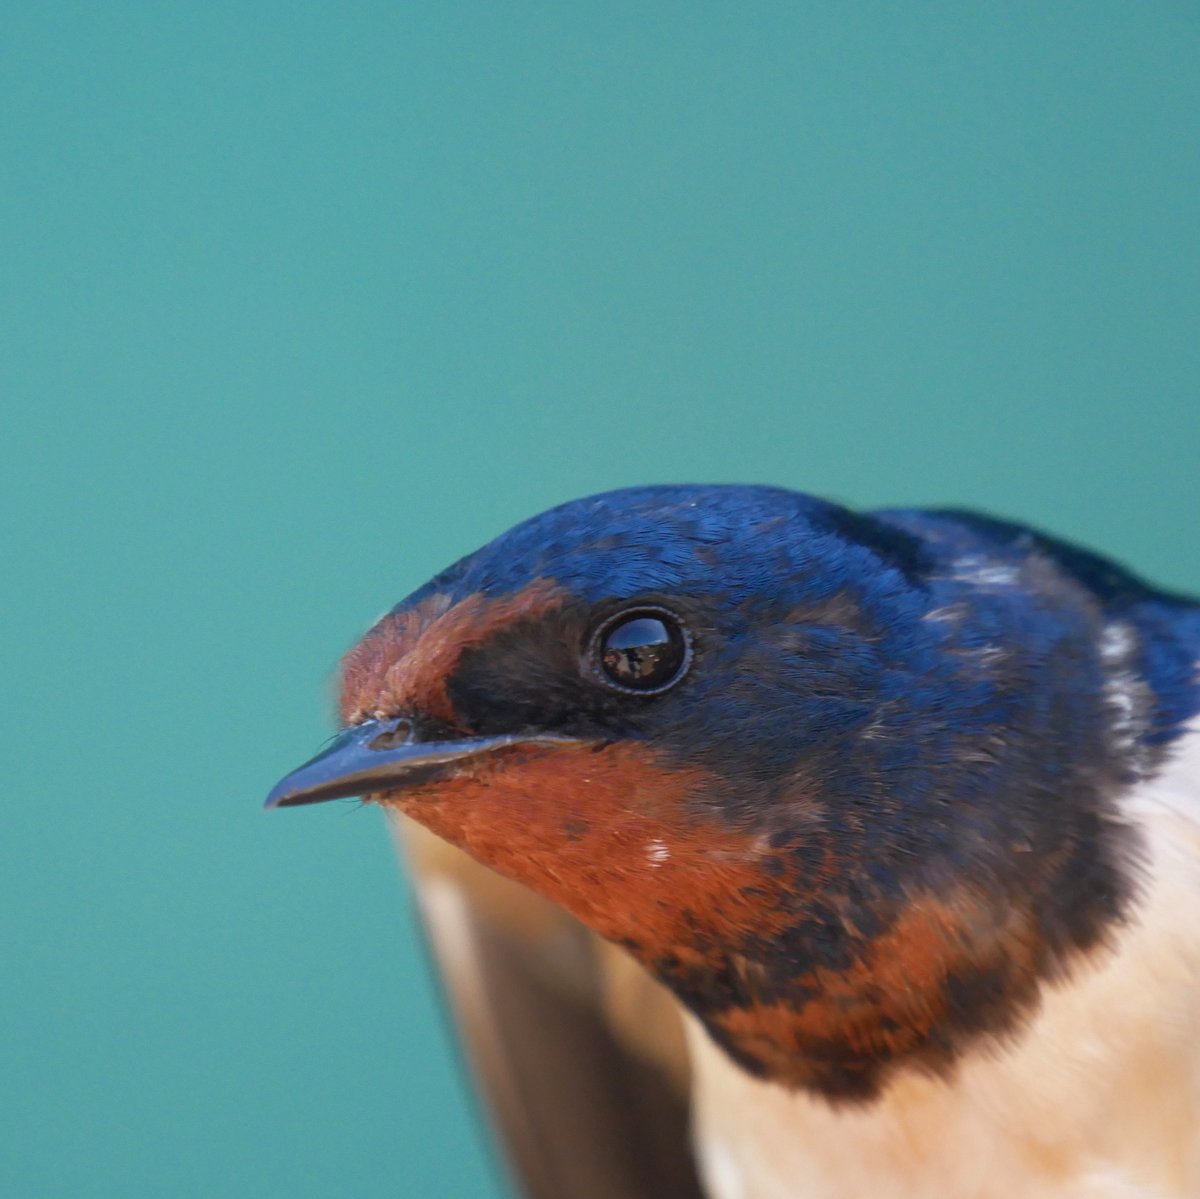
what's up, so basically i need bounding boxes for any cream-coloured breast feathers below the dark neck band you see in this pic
[688,729,1200,1199]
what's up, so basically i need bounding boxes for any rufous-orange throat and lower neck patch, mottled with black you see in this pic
[393,745,1040,1099]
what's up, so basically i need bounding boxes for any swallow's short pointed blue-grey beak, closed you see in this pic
[265,719,582,808]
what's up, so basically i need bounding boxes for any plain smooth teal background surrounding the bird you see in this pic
[0,9,1200,1199]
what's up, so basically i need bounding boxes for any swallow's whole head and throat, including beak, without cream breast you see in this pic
[269,486,1180,1101]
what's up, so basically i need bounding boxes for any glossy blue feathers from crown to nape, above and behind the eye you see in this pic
[402,486,1200,769]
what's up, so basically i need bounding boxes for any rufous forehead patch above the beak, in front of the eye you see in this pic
[340,578,569,724]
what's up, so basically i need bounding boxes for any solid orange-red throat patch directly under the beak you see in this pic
[385,744,788,974]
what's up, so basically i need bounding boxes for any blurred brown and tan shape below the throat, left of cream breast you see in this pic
[394,817,702,1199]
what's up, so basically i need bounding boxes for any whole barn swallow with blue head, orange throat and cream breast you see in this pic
[268,486,1200,1199]
